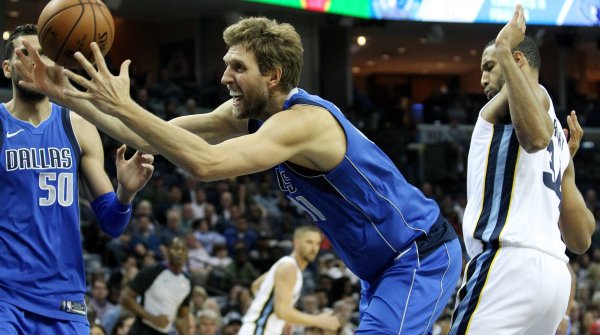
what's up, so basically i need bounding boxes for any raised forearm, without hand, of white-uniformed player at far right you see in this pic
[496,45,553,152]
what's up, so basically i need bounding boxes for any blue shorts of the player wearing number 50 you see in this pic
[0,301,90,335]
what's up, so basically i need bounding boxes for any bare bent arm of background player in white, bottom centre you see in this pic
[275,263,340,330]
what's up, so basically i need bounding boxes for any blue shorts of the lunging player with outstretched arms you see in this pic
[356,239,462,335]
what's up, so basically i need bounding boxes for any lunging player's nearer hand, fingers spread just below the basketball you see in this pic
[64,42,132,117]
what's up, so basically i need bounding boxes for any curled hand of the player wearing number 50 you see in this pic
[116,144,154,197]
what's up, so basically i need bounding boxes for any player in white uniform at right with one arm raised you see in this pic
[450,5,594,335]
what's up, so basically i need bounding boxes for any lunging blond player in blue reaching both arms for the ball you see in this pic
[19,18,462,334]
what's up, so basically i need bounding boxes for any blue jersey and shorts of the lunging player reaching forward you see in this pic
[249,88,462,334]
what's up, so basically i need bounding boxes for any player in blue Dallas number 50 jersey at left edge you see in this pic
[0,25,153,335]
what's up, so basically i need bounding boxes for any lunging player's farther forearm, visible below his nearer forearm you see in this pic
[67,99,155,154]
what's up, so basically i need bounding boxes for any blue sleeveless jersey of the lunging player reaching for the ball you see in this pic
[249,89,440,280]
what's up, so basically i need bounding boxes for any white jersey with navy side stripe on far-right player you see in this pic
[463,85,570,261]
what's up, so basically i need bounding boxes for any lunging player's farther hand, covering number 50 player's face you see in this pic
[15,39,73,106]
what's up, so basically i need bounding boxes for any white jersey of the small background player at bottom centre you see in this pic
[238,256,303,335]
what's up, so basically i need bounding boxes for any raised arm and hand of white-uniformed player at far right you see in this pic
[495,5,553,153]
